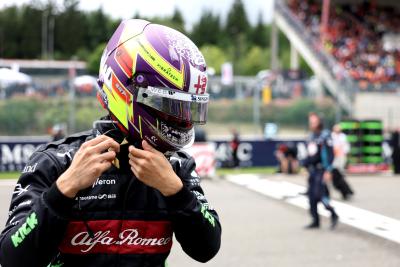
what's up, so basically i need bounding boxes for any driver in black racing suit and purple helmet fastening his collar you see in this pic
[0,20,221,267]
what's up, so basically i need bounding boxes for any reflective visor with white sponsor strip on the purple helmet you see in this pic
[136,86,210,124]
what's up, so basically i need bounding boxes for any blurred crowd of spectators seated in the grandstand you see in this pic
[288,0,400,89]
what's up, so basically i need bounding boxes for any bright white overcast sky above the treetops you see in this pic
[0,0,274,30]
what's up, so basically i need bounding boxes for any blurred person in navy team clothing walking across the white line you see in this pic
[302,113,339,229]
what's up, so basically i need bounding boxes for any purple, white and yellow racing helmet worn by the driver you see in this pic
[97,19,209,153]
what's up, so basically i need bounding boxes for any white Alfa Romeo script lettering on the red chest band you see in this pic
[71,229,171,253]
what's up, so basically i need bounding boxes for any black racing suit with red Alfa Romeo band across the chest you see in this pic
[0,122,221,267]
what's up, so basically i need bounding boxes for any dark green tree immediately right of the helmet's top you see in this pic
[191,10,223,47]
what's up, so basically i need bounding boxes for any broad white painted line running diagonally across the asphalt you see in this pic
[226,174,400,244]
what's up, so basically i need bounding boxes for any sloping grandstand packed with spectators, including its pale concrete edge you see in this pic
[272,0,400,127]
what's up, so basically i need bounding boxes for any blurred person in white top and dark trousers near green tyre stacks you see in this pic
[332,124,354,200]
